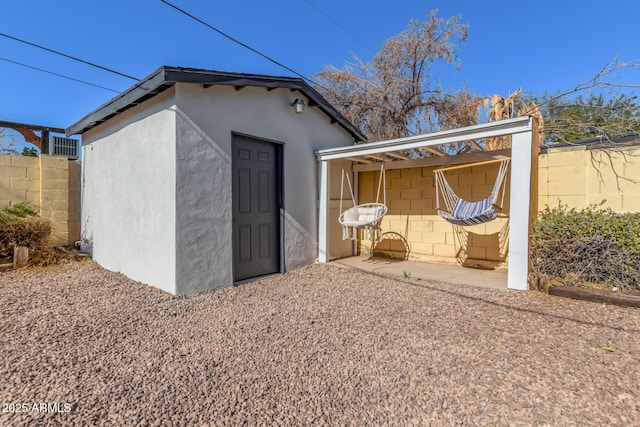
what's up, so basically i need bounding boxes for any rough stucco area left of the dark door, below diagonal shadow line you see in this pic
[172,106,234,294]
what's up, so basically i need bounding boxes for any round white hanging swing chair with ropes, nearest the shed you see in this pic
[338,165,387,242]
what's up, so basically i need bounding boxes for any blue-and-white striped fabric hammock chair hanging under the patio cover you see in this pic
[433,157,511,225]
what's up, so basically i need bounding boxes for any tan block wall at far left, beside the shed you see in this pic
[0,155,80,245]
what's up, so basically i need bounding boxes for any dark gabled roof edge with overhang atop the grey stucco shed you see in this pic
[66,66,366,141]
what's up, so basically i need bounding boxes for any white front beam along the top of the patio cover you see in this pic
[315,116,533,161]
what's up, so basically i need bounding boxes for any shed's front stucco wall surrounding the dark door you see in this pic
[175,84,353,293]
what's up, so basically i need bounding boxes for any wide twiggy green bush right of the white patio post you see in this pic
[531,205,640,290]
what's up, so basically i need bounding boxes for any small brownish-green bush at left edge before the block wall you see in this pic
[0,202,51,258]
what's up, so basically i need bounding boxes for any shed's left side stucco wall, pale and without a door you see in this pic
[82,91,176,293]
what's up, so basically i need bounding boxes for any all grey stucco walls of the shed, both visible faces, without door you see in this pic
[82,83,353,294]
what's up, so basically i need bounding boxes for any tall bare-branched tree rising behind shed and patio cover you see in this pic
[314,10,482,141]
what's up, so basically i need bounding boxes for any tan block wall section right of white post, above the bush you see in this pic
[538,146,640,212]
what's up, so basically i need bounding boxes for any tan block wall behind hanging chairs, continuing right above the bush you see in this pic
[358,146,640,265]
